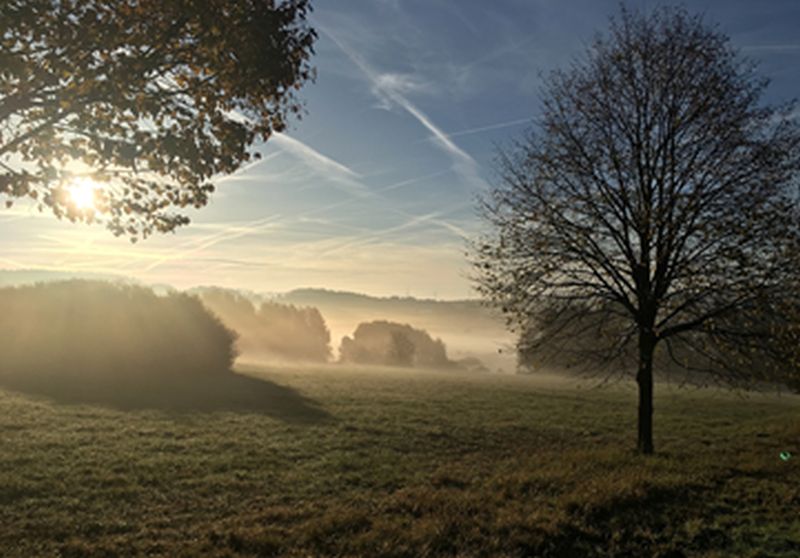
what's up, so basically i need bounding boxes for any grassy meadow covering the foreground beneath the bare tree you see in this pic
[0,366,800,558]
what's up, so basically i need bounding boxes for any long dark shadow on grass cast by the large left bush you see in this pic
[0,372,332,423]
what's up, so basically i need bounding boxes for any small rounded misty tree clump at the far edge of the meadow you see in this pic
[339,320,453,368]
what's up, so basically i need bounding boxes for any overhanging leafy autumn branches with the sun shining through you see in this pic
[0,0,316,238]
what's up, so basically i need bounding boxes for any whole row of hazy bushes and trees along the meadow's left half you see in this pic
[0,280,488,387]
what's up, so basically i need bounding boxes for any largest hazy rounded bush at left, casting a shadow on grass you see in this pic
[0,280,235,390]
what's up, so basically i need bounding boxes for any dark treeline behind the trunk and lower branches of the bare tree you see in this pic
[517,298,800,391]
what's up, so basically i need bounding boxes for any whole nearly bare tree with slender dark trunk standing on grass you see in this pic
[473,8,800,453]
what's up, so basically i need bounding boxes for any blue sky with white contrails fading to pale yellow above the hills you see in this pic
[0,0,800,299]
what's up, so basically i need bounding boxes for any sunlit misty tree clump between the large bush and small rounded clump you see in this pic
[197,288,331,362]
